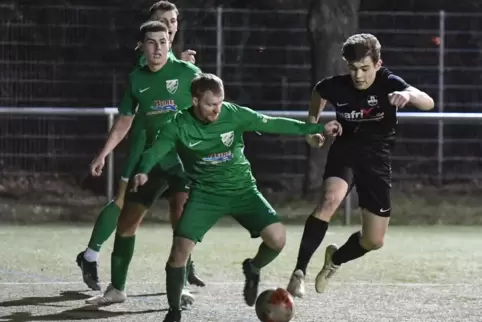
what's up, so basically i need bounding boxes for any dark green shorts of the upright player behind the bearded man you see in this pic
[125,155,190,208]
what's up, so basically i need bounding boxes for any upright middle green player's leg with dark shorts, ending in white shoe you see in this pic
[86,167,167,305]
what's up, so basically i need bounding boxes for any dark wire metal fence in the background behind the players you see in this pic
[0,4,482,195]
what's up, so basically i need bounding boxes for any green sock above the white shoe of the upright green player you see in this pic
[110,234,136,291]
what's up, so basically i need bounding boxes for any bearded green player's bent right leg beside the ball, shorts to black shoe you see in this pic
[230,188,286,306]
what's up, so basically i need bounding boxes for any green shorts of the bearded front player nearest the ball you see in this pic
[174,187,281,242]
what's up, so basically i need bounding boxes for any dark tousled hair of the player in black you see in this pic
[341,34,382,63]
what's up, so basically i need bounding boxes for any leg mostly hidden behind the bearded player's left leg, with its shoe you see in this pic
[167,166,206,287]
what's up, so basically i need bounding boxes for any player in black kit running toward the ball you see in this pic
[287,34,434,297]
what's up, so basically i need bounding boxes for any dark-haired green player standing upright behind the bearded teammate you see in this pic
[87,21,200,305]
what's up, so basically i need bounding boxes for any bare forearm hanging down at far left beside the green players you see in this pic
[90,115,134,177]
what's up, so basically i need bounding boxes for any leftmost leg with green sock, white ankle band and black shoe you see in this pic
[76,180,127,290]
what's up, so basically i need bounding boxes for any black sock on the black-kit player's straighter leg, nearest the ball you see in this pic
[295,216,328,275]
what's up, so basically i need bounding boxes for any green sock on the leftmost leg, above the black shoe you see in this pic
[88,201,120,252]
